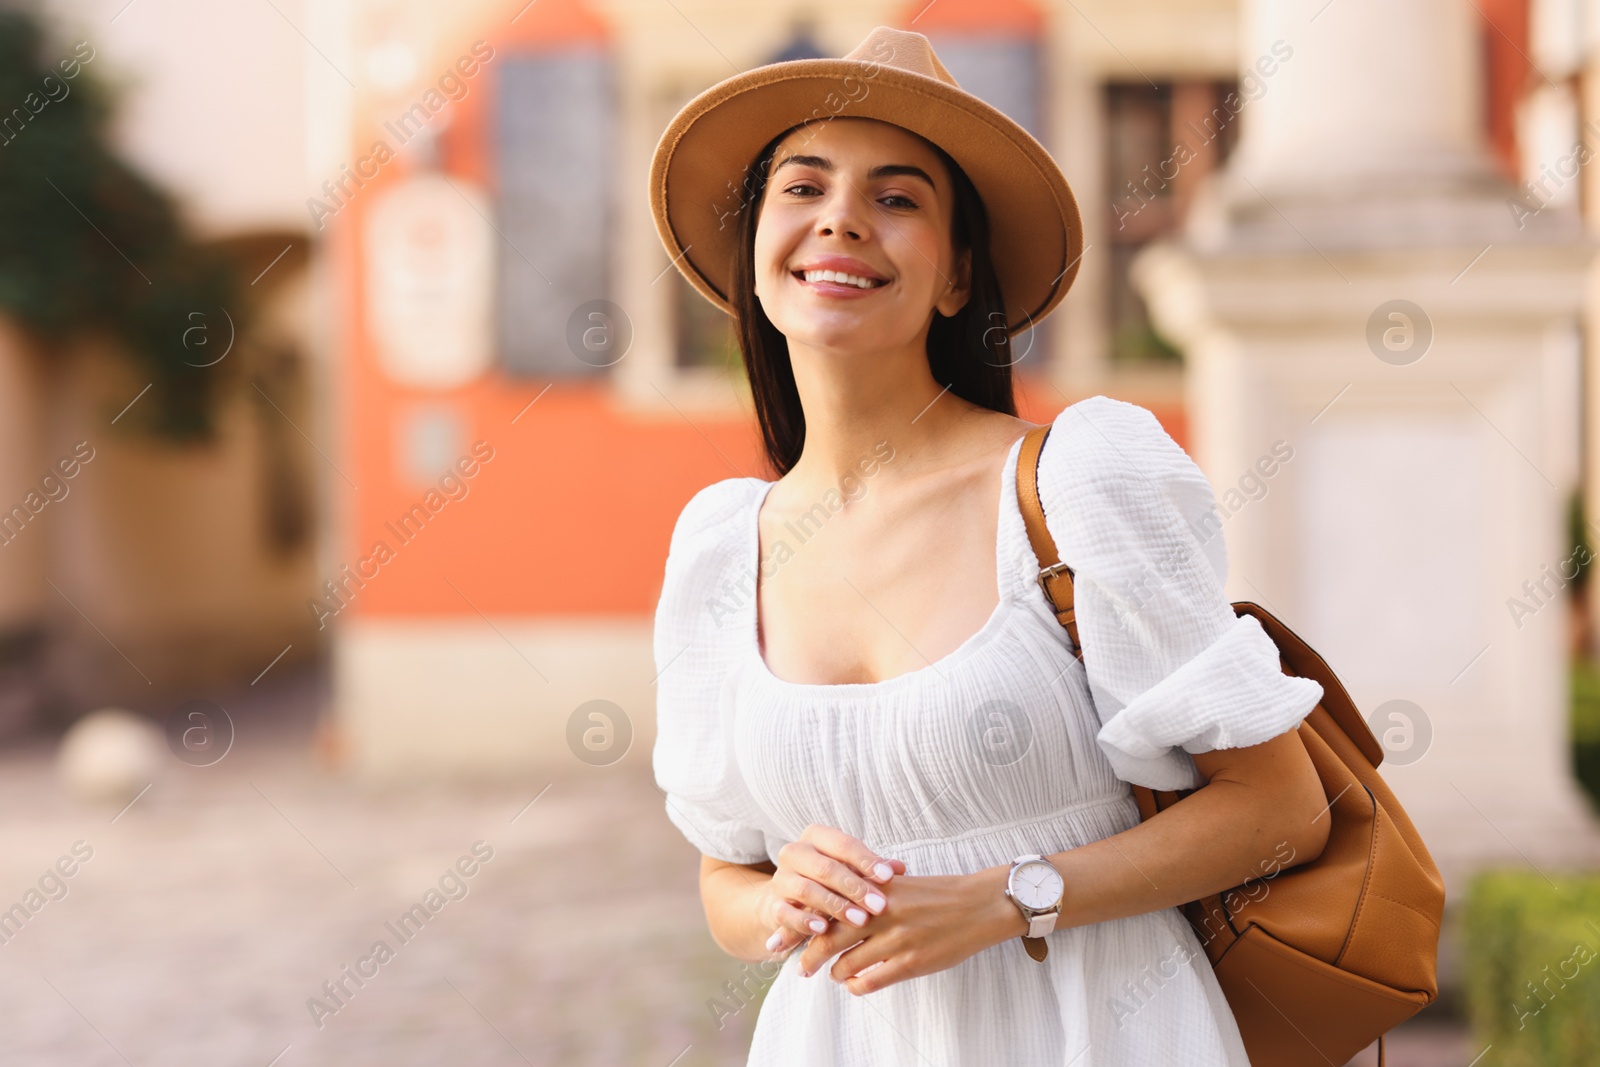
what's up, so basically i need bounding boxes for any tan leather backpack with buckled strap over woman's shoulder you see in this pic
[1016,426,1445,1067]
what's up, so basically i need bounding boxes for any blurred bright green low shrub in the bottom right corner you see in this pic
[1461,869,1600,1067]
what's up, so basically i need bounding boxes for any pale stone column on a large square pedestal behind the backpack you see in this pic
[1136,0,1600,897]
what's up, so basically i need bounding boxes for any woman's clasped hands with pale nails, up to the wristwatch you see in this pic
[760,824,1027,997]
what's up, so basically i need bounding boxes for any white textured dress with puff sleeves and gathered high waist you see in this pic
[654,397,1322,1067]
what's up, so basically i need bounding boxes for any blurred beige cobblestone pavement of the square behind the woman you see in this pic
[0,671,1470,1067]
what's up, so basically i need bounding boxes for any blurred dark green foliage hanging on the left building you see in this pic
[0,8,248,442]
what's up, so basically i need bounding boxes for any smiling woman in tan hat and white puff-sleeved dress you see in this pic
[651,27,1328,1067]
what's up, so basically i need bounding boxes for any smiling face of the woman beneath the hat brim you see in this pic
[754,118,971,352]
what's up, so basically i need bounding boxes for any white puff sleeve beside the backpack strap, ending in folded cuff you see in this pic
[1038,397,1322,790]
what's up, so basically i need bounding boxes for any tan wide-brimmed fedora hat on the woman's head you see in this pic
[650,26,1083,334]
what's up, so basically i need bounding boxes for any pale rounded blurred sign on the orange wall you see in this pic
[363,171,494,389]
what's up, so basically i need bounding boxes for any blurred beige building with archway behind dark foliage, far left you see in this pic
[0,0,323,733]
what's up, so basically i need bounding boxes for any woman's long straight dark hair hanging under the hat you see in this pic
[728,120,1016,477]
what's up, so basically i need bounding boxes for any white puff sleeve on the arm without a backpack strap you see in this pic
[651,478,768,864]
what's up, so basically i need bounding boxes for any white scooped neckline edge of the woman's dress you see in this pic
[744,432,1027,696]
